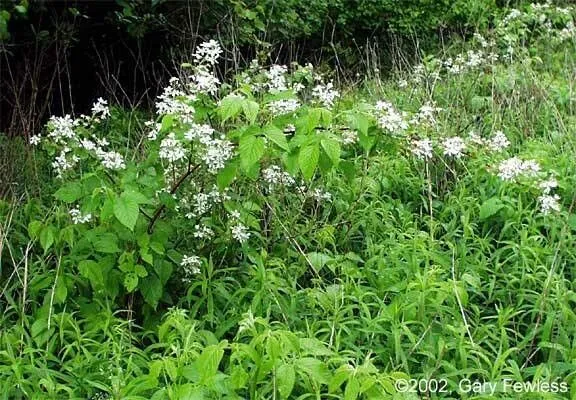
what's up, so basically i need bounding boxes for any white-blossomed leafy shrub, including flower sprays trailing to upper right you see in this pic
[31,1,568,307]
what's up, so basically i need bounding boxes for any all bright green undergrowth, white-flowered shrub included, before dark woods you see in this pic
[0,4,576,400]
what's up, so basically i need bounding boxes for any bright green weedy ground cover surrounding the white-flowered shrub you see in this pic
[0,3,576,400]
